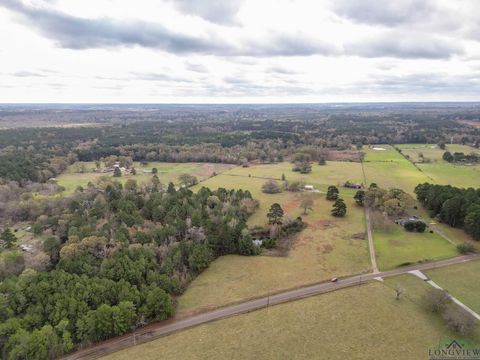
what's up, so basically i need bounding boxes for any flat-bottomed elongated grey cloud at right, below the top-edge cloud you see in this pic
[345,32,464,59]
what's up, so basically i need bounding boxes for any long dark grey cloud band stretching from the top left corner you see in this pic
[0,0,335,56]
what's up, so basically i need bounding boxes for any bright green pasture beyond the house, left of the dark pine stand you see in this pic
[362,145,432,195]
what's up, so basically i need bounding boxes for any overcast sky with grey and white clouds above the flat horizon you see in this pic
[0,0,480,103]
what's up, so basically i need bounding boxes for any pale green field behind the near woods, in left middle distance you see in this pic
[57,162,234,193]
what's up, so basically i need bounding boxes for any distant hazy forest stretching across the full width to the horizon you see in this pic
[0,104,480,182]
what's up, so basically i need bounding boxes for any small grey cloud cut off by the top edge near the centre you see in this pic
[171,0,242,24]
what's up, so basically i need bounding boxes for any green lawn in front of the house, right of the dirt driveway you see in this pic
[373,225,458,270]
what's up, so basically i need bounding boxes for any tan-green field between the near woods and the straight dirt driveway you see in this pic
[178,164,370,314]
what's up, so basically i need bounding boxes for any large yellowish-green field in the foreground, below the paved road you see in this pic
[104,282,480,360]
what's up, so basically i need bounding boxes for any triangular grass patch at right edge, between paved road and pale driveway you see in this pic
[426,261,480,313]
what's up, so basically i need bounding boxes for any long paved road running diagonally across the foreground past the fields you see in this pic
[64,255,480,360]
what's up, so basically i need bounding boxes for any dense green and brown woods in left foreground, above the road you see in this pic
[0,181,257,359]
